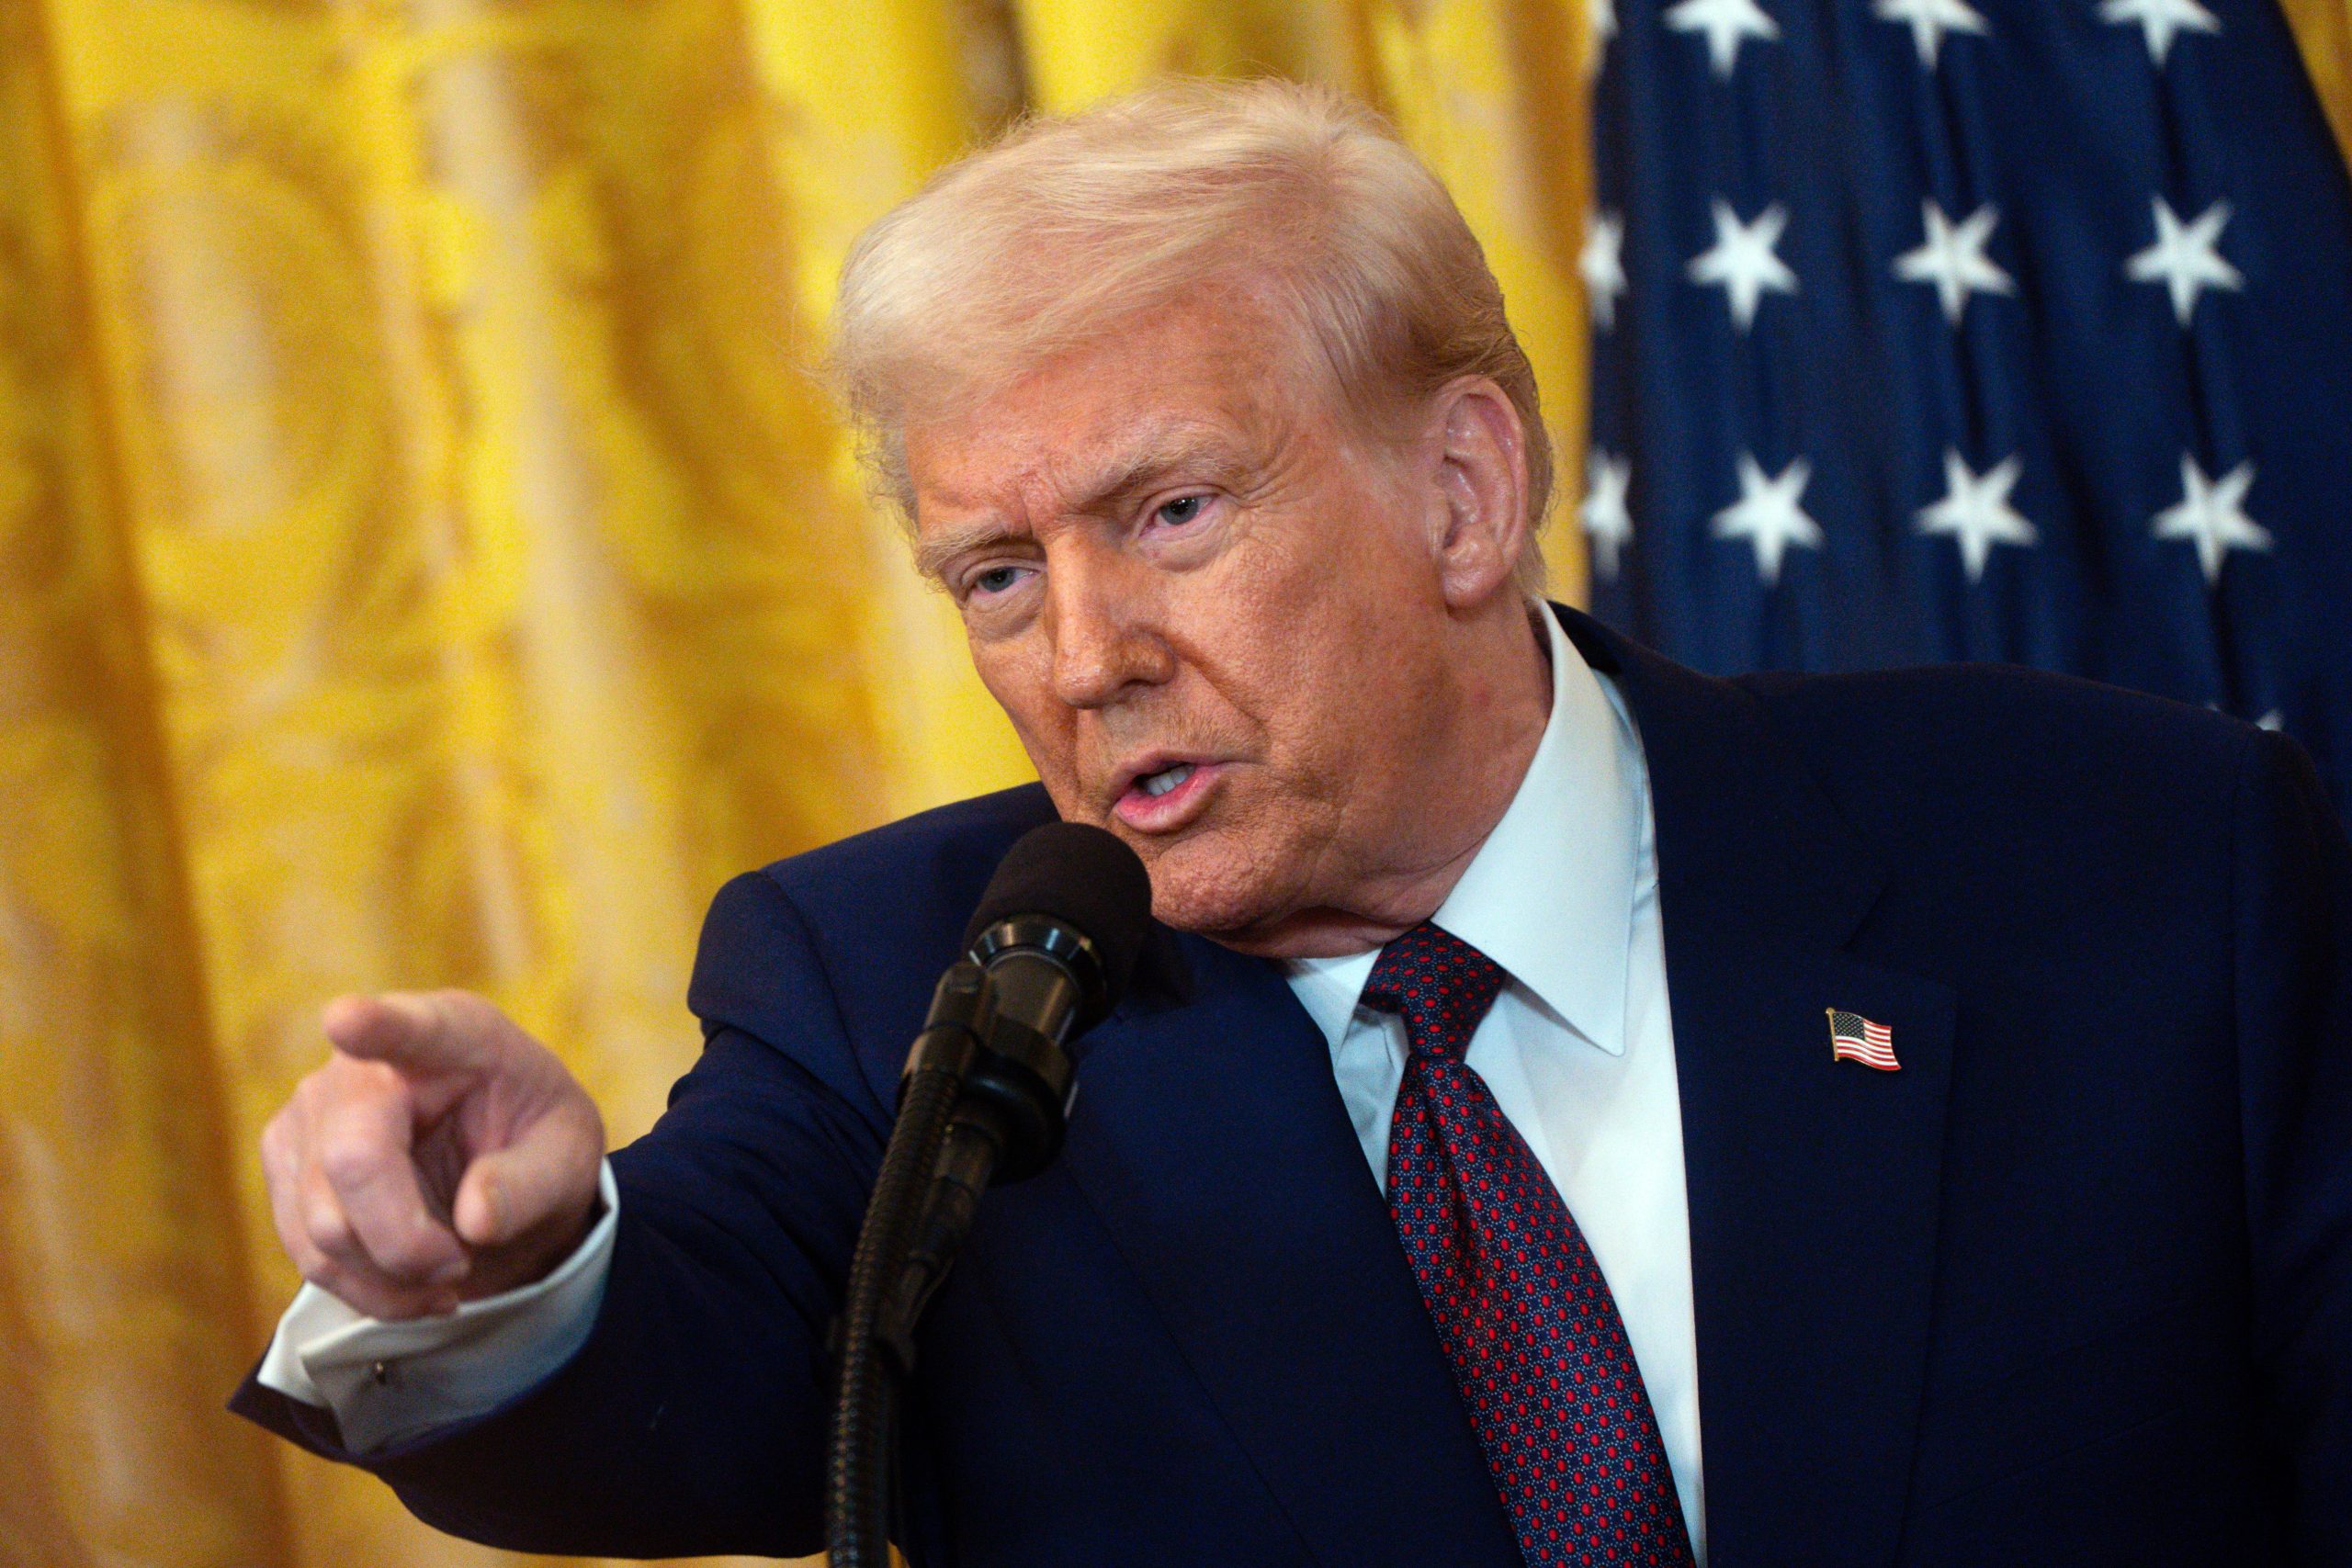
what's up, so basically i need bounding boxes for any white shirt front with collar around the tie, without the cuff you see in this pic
[1289,611,1708,1568]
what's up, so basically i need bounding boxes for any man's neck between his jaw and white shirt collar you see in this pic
[1204,604,1553,959]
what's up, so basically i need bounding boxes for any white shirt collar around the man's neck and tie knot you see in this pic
[1289,606,1642,1055]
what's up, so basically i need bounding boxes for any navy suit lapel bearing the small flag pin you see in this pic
[1564,614,1954,1568]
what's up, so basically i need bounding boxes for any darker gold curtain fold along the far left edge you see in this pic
[0,0,291,1568]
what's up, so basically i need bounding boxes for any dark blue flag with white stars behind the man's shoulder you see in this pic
[1583,0,2352,816]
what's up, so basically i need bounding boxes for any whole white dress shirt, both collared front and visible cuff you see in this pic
[261,611,1708,1568]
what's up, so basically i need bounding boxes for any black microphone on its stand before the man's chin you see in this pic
[826,823,1152,1568]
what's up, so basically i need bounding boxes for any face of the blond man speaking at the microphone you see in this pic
[908,299,1514,954]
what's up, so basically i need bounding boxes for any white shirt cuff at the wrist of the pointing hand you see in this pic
[256,1159,621,1453]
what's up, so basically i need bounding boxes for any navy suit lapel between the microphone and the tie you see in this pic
[1066,938,1520,1568]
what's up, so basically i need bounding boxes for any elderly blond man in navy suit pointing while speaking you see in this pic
[224,85,2352,1568]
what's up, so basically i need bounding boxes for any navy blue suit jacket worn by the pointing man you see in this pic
[235,611,2352,1568]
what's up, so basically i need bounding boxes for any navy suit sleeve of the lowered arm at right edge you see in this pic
[2234,733,2352,1563]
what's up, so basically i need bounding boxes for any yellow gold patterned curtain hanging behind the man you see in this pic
[0,0,2352,1568]
